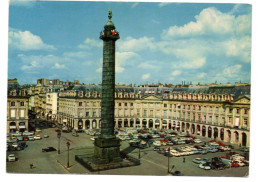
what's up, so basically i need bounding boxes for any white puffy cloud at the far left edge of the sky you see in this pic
[8,29,56,51]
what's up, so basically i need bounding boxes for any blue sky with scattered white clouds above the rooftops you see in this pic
[8,0,252,85]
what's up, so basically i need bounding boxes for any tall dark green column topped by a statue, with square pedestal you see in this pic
[94,10,122,164]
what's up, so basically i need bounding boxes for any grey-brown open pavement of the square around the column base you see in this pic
[6,128,249,177]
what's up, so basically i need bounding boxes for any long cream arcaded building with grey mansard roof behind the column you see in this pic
[58,85,250,146]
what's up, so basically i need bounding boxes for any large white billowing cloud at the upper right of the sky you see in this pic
[162,7,251,39]
